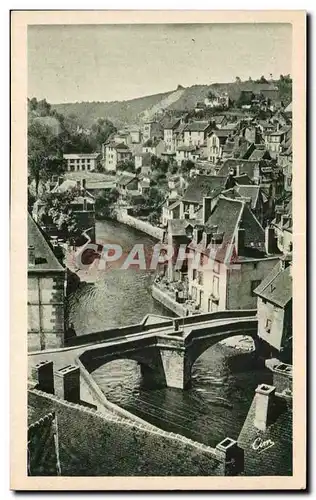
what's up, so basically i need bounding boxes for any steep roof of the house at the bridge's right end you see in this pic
[255,260,292,307]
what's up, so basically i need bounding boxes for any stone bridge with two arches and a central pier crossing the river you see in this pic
[30,310,258,389]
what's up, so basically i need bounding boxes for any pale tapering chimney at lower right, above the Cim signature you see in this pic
[254,384,275,431]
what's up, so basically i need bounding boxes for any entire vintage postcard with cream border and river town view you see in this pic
[11,10,306,491]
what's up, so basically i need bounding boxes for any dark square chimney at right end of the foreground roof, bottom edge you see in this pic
[215,437,244,476]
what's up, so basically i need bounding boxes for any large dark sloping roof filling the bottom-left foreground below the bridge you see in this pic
[28,389,225,476]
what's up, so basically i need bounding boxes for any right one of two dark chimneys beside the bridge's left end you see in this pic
[55,365,80,403]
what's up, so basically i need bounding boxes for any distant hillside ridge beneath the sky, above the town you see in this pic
[52,80,292,127]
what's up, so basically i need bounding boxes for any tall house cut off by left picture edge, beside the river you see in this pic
[27,214,66,351]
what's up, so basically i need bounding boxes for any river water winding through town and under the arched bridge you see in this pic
[69,221,266,446]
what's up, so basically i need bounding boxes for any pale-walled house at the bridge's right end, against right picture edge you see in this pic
[254,257,293,361]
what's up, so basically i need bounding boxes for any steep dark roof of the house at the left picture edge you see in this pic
[27,214,64,272]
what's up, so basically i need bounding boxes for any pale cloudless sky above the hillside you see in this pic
[28,23,292,103]
